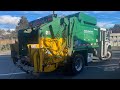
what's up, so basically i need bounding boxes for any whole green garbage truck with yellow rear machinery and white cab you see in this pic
[11,12,112,75]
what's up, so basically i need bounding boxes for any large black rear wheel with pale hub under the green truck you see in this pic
[72,54,84,75]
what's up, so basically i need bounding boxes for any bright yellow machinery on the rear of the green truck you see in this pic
[28,38,68,72]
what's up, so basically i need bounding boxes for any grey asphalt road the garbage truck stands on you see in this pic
[0,51,120,79]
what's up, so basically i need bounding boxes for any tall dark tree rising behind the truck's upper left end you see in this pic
[16,16,29,31]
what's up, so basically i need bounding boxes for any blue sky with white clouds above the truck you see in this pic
[0,11,120,30]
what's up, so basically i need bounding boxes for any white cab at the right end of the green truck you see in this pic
[98,28,112,60]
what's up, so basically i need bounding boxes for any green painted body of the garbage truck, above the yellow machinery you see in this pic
[18,13,99,55]
